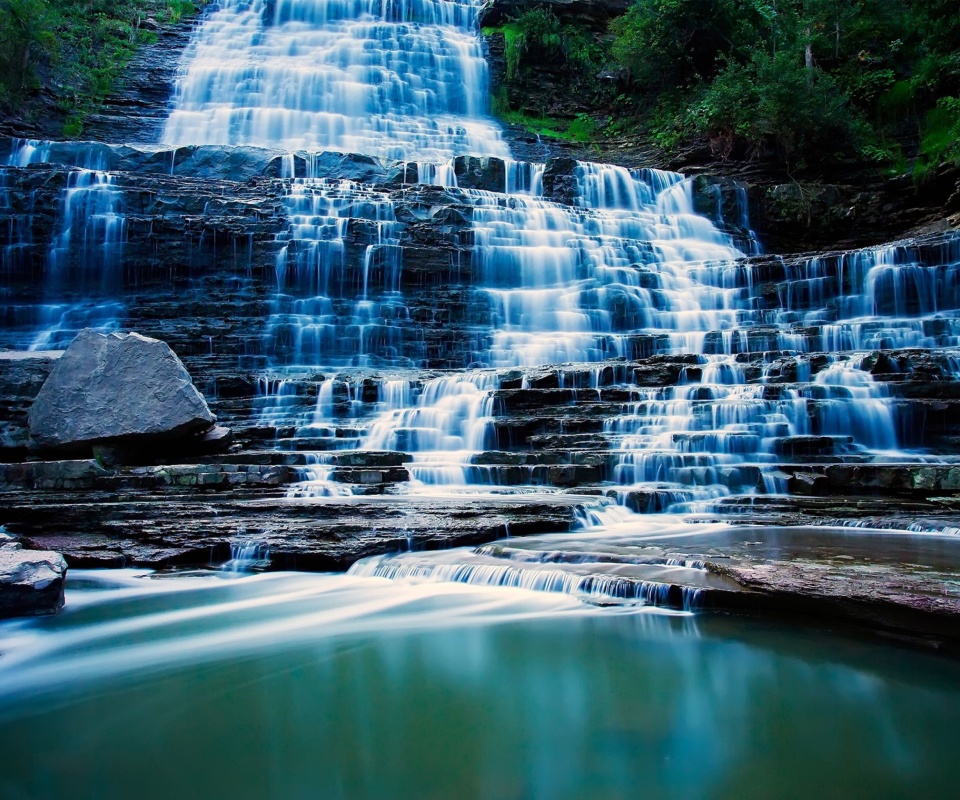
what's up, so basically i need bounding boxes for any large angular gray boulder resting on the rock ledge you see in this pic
[30,329,216,450]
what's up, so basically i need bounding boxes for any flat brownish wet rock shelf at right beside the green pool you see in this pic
[513,520,960,648]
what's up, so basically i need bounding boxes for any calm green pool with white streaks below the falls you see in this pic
[0,571,960,800]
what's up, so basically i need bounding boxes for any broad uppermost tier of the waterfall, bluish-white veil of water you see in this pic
[163,0,509,163]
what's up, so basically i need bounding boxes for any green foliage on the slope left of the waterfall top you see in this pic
[0,0,206,136]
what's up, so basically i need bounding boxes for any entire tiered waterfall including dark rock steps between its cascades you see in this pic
[0,0,960,588]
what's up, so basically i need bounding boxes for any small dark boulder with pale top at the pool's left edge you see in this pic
[0,539,67,618]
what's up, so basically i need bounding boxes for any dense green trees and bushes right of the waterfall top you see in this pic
[610,0,960,167]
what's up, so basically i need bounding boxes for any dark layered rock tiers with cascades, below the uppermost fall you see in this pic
[4,143,960,540]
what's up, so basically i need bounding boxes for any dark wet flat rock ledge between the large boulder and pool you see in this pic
[7,495,585,571]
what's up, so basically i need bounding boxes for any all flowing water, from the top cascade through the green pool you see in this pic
[0,0,960,800]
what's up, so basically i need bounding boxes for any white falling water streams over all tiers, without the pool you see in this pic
[0,0,960,568]
